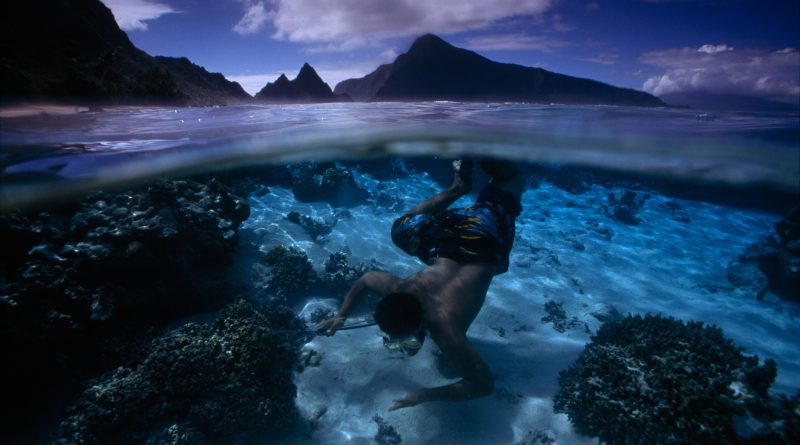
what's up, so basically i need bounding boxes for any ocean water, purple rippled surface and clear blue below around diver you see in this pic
[0,102,800,444]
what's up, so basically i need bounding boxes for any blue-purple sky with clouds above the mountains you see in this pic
[102,0,800,99]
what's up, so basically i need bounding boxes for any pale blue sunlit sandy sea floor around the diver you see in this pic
[234,168,800,445]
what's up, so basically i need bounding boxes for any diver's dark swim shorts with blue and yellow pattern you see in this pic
[392,184,522,274]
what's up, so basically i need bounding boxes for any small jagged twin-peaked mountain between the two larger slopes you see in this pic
[255,63,349,103]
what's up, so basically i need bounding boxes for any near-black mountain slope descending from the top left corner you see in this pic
[0,0,250,105]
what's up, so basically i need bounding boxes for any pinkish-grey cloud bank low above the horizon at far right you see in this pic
[640,44,800,98]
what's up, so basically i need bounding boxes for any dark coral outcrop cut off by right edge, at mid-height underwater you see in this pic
[726,207,800,301]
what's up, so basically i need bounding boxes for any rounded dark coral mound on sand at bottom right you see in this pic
[554,315,800,444]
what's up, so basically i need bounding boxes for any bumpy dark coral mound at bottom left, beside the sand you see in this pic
[57,301,303,444]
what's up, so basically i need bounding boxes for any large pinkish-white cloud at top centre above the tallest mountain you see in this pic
[272,0,554,50]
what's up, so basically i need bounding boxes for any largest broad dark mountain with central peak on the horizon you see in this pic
[335,34,665,106]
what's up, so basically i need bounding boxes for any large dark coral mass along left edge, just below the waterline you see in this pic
[0,180,249,438]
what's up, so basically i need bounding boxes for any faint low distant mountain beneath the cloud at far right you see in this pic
[659,91,800,111]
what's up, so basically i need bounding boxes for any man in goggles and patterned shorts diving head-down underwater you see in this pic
[318,160,525,411]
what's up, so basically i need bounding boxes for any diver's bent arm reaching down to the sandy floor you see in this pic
[389,330,494,411]
